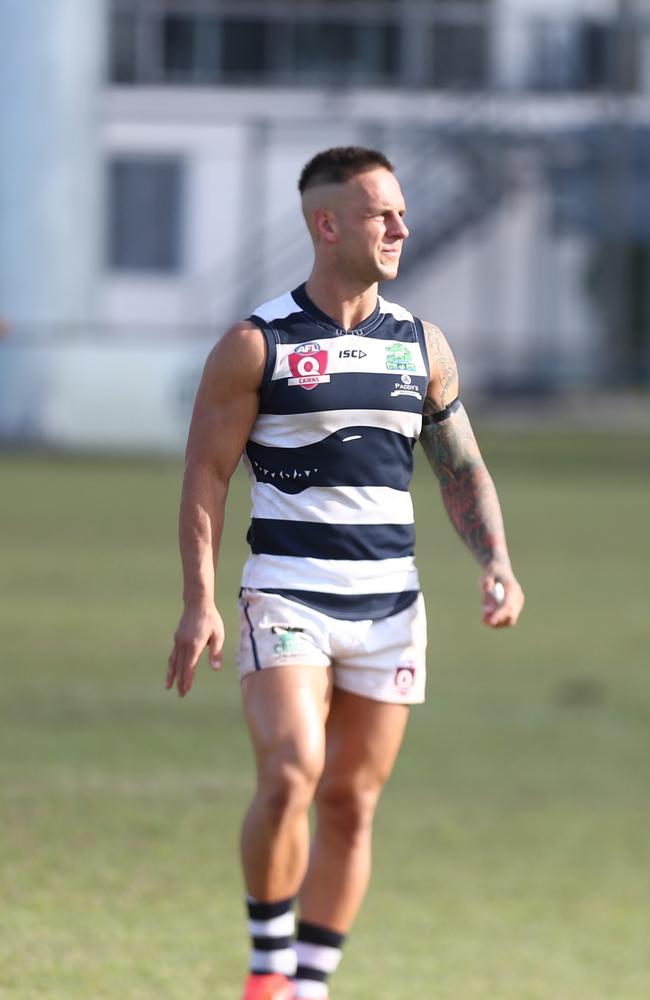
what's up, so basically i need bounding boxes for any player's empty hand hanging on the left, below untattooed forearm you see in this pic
[165,604,224,698]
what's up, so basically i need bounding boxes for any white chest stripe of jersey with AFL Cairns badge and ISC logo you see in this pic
[271,334,427,381]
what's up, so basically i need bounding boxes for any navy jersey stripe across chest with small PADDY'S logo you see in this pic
[260,374,427,415]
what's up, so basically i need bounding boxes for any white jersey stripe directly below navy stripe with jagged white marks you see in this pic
[253,483,414,524]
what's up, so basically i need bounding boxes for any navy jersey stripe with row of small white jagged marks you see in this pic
[246,427,415,496]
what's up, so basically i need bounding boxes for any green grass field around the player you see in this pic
[0,433,650,1000]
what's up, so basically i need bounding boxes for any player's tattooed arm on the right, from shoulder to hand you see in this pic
[420,323,524,628]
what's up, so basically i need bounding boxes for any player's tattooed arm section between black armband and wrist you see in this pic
[420,406,510,569]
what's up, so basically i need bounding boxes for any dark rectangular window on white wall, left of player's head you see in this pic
[108,156,183,274]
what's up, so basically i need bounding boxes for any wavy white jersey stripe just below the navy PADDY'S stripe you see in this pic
[250,410,422,448]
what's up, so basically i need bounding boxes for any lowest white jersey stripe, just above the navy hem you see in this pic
[242,556,420,595]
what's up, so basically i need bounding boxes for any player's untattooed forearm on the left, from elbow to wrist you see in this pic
[179,463,228,604]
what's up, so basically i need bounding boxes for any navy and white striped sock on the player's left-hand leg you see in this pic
[246,896,296,976]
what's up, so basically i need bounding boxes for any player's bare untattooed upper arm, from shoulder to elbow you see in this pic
[186,323,266,480]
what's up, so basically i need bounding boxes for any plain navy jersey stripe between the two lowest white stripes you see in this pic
[248,517,415,559]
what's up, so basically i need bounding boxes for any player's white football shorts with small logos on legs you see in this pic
[237,589,427,705]
